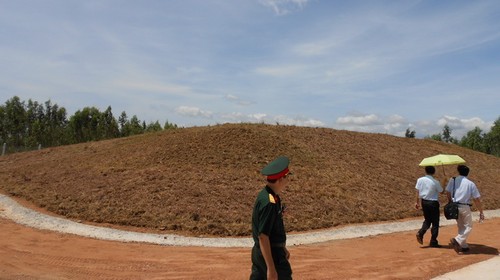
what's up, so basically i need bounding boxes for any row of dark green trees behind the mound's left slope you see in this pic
[0,96,177,152]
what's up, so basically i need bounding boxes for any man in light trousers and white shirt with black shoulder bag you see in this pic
[446,165,484,253]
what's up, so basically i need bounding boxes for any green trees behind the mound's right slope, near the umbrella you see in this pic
[405,117,500,157]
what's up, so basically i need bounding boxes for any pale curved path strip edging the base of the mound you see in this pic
[0,194,500,247]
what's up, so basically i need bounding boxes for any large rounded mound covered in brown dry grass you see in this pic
[0,124,500,236]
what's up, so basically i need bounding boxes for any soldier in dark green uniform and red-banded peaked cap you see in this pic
[250,157,292,280]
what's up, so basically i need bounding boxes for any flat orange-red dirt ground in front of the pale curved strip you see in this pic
[0,219,500,279]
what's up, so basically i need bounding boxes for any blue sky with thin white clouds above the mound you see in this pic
[0,0,500,137]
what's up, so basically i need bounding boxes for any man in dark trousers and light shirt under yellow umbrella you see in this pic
[415,166,443,248]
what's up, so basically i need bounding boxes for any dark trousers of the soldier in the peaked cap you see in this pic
[250,245,292,280]
